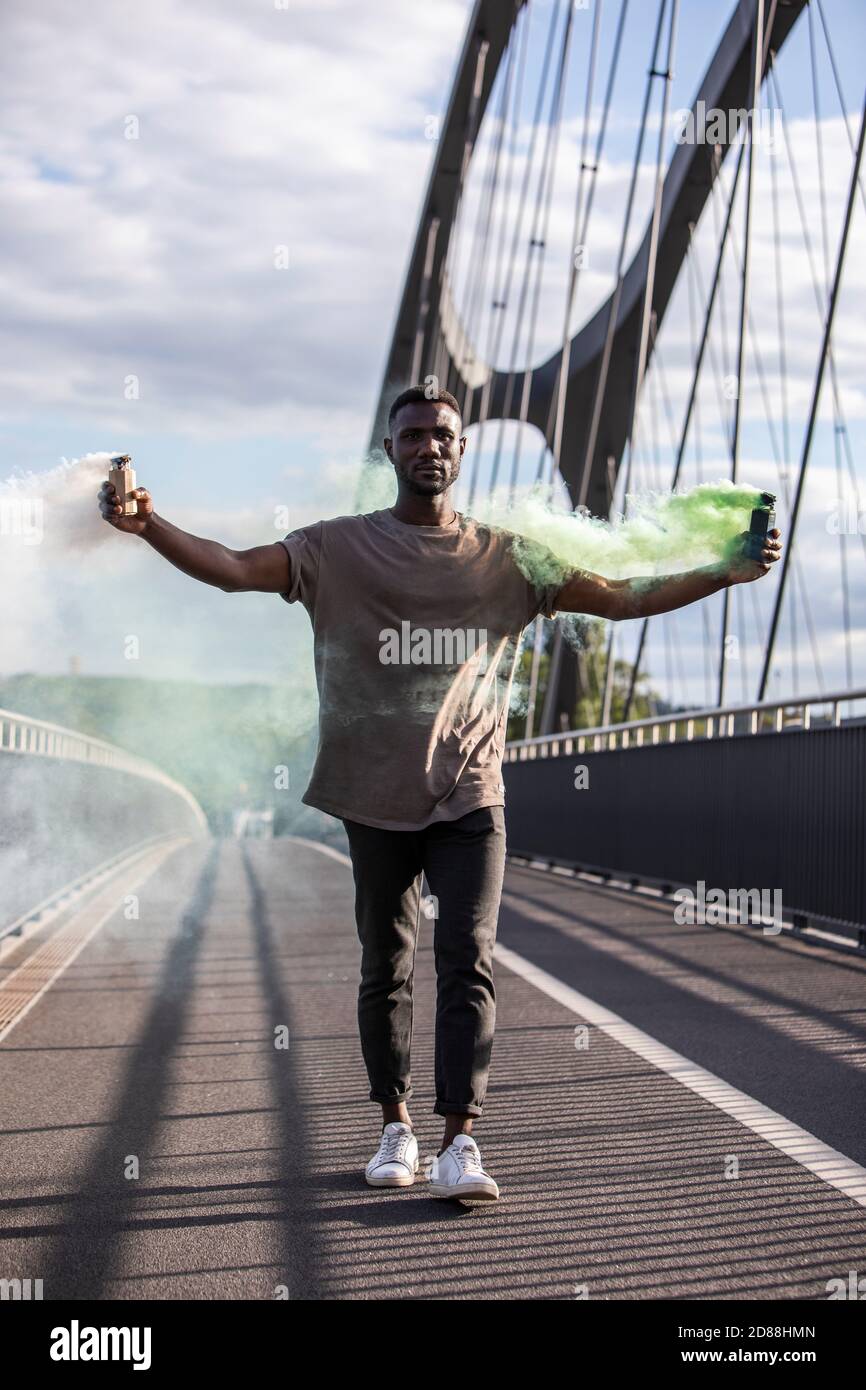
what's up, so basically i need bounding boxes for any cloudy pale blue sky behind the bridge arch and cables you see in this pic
[0,0,866,711]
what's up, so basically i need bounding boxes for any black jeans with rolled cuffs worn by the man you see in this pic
[343,806,505,1115]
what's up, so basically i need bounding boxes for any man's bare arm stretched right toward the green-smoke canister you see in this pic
[555,530,781,621]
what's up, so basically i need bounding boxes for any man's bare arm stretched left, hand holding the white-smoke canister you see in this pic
[99,482,289,594]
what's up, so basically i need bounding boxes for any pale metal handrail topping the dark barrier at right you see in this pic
[503,689,866,763]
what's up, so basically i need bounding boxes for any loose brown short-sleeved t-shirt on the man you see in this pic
[279,509,564,830]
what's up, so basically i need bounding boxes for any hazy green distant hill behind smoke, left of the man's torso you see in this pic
[0,674,345,845]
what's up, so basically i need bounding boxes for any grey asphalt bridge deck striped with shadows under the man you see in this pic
[0,840,866,1300]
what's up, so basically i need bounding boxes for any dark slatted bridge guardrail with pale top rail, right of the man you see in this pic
[502,691,866,940]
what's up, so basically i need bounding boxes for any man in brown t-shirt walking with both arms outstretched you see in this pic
[99,386,780,1201]
